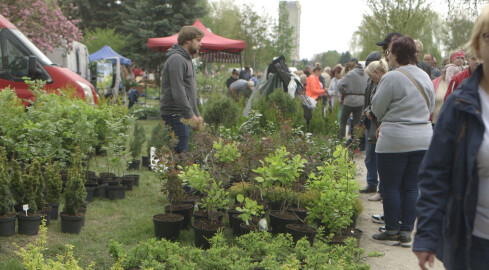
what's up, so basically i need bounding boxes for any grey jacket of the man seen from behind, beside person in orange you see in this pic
[338,65,367,107]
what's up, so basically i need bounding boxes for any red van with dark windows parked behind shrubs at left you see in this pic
[0,15,97,105]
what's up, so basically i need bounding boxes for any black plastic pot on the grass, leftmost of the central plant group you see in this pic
[153,213,185,240]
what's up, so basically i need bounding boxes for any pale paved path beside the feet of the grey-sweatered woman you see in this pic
[355,152,445,270]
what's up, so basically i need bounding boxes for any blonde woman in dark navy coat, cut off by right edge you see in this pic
[413,5,489,270]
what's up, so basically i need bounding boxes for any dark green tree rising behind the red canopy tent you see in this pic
[120,0,207,70]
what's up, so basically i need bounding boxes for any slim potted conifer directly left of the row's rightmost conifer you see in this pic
[44,159,63,220]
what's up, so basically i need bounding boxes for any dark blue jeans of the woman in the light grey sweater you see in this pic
[377,150,426,231]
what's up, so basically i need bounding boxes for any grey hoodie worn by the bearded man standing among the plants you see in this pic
[160,44,200,119]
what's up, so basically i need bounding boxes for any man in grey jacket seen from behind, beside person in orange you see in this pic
[338,58,367,139]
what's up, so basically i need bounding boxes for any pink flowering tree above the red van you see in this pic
[0,0,83,52]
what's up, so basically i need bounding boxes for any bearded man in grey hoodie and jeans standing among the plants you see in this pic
[160,26,204,153]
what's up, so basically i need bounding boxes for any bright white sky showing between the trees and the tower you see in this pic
[211,0,446,59]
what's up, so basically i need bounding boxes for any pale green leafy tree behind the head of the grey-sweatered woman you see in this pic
[355,0,441,59]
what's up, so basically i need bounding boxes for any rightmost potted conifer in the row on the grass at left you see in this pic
[59,147,87,234]
